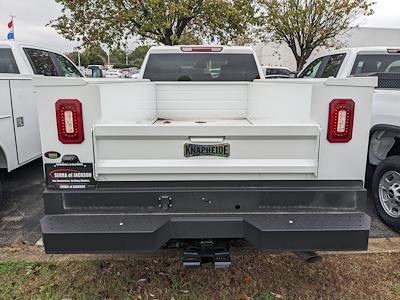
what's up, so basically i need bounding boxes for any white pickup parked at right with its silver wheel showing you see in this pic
[299,47,400,231]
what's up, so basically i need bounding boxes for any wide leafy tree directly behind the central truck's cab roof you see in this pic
[50,0,261,47]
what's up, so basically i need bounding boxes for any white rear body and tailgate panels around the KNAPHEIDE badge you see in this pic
[35,74,376,181]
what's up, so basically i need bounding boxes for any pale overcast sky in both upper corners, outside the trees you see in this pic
[0,0,400,52]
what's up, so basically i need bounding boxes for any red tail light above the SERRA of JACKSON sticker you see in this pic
[56,99,83,144]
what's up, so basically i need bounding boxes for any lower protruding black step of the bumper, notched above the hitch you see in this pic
[41,213,370,253]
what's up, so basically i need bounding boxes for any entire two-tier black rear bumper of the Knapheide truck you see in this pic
[41,181,370,253]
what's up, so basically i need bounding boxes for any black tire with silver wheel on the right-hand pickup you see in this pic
[372,156,400,232]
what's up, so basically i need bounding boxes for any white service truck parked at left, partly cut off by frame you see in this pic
[0,41,82,203]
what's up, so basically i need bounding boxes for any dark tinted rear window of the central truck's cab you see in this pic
[143,53,259,81]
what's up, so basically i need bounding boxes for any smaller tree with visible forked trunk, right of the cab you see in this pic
[263,0,374,71]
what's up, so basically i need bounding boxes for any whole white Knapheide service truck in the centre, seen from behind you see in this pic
[35,46,377,267]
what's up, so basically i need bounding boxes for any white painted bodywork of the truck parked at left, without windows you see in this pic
[0,41,81,171]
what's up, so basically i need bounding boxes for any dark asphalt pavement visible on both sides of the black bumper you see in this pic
[0,160,398,246]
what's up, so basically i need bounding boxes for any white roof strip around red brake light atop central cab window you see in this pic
[149,45,254,54]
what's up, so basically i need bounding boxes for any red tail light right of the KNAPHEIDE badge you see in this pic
[328,99,355,143]
